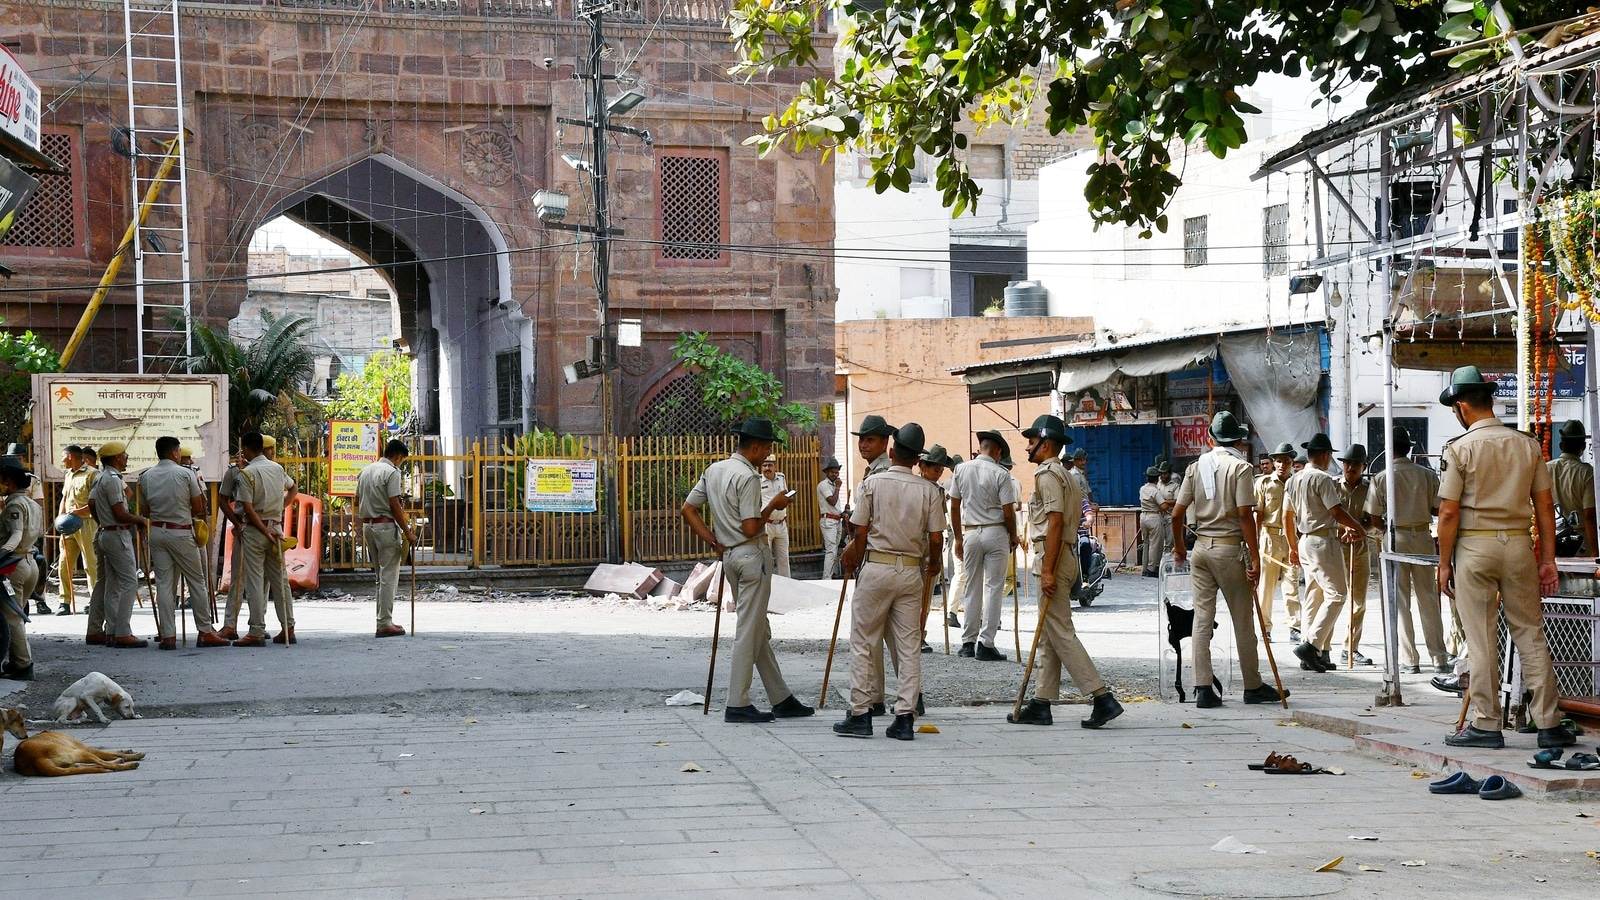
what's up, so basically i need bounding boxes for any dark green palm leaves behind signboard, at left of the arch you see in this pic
[189,309,317,434]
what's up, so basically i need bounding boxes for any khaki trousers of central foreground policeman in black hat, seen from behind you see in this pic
[850,554,928,716]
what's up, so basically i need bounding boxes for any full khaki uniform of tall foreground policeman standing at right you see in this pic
[1438,418,1562,732]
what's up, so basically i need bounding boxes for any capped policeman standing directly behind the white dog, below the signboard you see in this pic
[88,440,150,649]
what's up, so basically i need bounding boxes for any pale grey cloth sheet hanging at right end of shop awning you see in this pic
[1221,330,1322,447]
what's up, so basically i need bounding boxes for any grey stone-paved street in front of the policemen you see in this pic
[0,578,1600,898]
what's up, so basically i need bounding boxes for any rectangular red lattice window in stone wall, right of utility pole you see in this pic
[659,152,728,266]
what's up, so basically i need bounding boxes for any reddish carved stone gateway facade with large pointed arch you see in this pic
[0,0,835,445]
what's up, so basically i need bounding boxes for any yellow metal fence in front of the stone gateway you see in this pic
[278,436,822,570]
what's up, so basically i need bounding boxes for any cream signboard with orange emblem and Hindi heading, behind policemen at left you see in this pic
[34,373,227,482]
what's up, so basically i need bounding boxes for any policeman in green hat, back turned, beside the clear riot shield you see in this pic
[1173,410,1282,709]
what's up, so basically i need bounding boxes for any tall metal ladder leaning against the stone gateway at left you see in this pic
[122,0,192,375]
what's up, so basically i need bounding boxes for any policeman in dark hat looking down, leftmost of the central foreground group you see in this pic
[682,418,816,722]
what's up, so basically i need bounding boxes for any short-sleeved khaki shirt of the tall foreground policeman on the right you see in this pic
[1438,416,1550,532]
